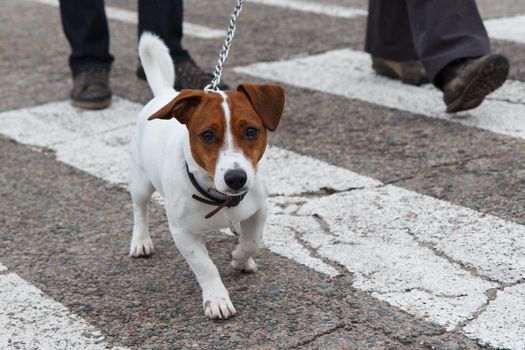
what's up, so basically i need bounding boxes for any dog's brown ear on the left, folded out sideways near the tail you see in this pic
[148,90,204,124]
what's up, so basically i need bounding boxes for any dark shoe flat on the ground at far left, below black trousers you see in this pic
[69,68,111,109]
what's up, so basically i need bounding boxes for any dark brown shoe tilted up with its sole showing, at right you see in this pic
[437,54,509,113]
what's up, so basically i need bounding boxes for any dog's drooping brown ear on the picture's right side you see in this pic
[237,84,285,131]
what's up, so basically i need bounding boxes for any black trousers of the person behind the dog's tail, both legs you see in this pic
[60,0,190,76]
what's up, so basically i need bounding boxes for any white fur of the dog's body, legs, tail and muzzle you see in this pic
[129,34,268,318]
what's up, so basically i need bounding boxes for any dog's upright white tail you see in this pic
[139,32,175,96]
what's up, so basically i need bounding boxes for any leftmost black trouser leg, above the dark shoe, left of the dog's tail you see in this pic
[60,0,113,76]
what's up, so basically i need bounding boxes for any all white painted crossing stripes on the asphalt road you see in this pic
[0,0,525,349]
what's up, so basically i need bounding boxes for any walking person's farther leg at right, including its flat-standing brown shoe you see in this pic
[365,0,428,85]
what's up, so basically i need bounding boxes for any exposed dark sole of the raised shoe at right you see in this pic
[447,55,509,113]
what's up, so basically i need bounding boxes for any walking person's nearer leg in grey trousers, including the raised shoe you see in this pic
[405,0,509,112]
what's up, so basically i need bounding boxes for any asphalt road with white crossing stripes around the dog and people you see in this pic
[0,0,525,349]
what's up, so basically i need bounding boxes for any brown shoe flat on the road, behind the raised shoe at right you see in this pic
[372,56,429,86]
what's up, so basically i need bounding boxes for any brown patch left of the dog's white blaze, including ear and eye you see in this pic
[148,90,226,179]
